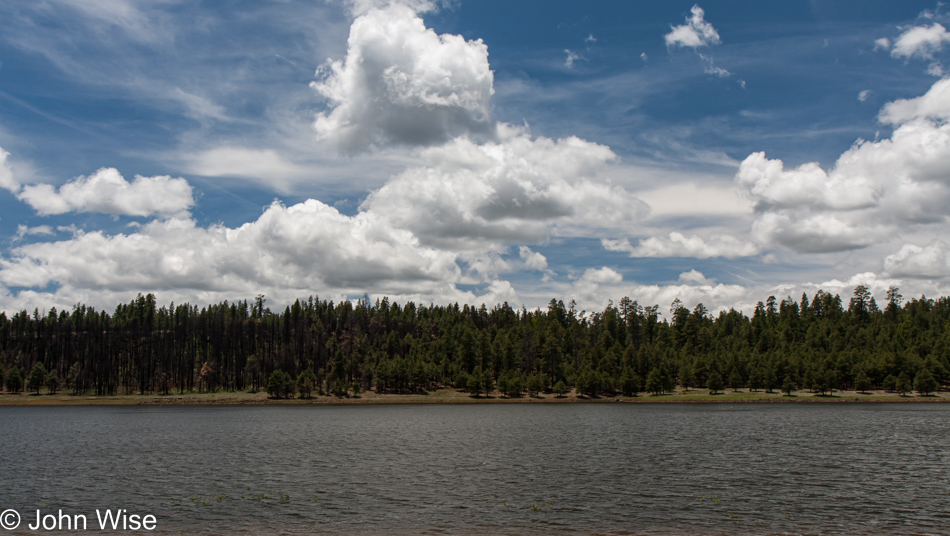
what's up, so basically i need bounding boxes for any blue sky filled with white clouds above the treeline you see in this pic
[0,0,950,314]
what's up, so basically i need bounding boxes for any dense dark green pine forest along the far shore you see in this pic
[0,286,950,397]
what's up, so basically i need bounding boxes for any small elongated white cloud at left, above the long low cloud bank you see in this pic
[17,168,194,216]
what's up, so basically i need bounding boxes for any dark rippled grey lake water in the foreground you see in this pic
[0,404,950,535]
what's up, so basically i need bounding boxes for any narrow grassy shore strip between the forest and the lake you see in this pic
[0,389,950,406]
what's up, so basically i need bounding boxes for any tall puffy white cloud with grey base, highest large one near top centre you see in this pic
[311,3,495,154]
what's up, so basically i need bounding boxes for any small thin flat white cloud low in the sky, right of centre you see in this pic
[601,232,759,259]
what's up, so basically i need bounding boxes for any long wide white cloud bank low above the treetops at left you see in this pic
[0,200,459,295]
